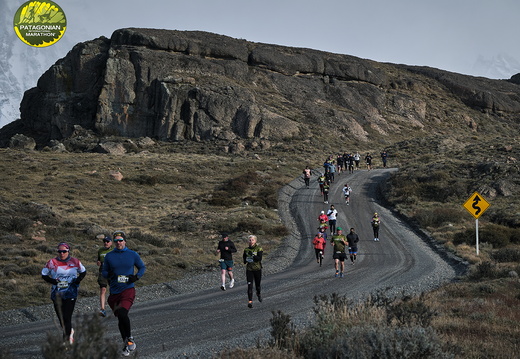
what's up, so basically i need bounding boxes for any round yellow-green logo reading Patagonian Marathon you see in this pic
[13,1,67,47]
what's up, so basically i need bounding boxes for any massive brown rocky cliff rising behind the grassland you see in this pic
[0,29,520,146]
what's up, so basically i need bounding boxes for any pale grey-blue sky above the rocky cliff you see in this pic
[56,0,520,75]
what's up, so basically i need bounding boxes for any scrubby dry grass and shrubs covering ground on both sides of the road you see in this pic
[0,129,520,358]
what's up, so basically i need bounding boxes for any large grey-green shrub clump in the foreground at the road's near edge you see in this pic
[294,293,452,359]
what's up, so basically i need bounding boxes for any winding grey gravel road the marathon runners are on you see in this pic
[0,169,466,358]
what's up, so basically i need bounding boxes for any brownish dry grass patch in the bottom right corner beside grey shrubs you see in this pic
[427,278,520,358]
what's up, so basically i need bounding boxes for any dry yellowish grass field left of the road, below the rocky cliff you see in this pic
[0,147,301,310]
